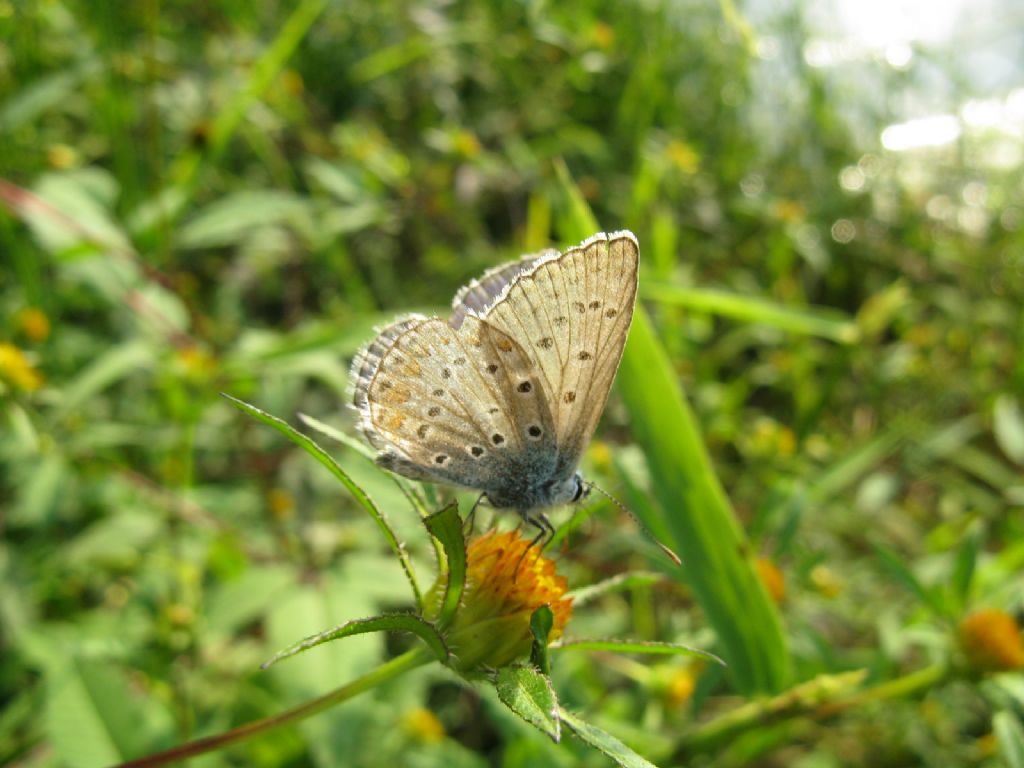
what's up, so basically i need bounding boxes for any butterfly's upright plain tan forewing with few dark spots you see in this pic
[468,231,640,470]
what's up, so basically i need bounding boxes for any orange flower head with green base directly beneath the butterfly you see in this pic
[432,531,572,673]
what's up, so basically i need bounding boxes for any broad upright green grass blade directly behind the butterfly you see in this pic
[555,162,790,693]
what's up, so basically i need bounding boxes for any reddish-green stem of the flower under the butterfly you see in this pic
[117,648,433,768]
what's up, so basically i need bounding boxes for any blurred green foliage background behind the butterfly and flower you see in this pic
[0,0,1024,768]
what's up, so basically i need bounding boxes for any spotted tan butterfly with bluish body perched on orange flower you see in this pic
[351,230,640,536]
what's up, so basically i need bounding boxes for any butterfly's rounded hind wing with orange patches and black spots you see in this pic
[352,315,555,492]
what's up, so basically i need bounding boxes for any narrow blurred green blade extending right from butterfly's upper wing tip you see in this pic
[640,282,859,344]
